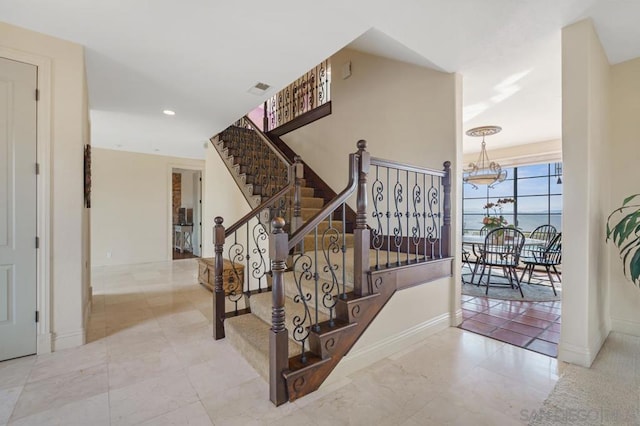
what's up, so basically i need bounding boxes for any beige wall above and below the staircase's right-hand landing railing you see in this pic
[283,49,462,362]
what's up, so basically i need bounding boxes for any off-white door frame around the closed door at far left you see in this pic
[0,46,52,354]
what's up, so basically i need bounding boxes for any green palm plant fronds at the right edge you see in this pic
[607,194,640,287]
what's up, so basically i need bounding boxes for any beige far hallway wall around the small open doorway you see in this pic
[91,148,204,266]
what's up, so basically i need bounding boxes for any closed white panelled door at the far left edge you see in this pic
[0,58,37,361]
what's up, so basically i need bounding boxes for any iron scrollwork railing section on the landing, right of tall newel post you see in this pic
[370,158,448,269]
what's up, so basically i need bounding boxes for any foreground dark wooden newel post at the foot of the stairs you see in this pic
[269,217,289,405]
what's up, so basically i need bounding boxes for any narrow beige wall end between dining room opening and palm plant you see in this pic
[558,21,610,366]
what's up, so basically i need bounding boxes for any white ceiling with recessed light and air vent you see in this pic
[0,0,640,158]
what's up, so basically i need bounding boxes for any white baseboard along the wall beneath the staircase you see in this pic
[323,312,450,386]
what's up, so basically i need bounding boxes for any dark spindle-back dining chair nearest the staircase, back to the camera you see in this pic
[472,228,524,298]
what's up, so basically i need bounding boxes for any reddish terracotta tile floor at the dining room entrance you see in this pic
[460,294,561,357]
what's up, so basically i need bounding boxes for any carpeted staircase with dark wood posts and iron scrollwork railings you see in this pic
[212,117,452,405]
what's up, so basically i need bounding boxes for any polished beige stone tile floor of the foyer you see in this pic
[0,259,564,426]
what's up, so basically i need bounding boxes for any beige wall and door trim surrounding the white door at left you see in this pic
[0,23,90,352]
